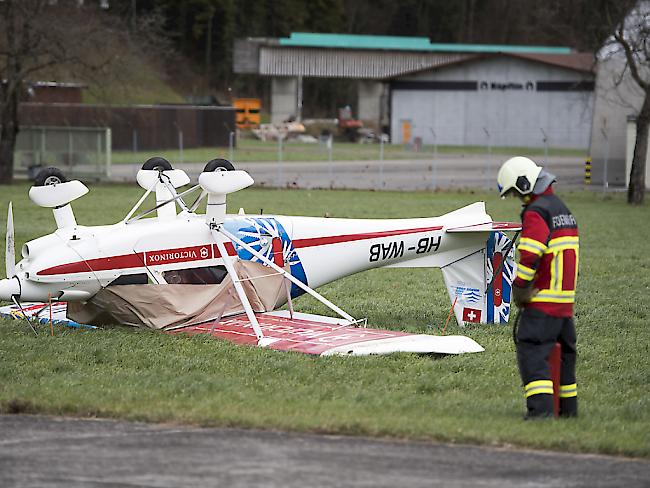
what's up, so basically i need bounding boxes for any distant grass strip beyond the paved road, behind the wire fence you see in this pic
[112,138,586,164]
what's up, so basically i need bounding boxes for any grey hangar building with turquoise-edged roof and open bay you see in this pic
[234,33,594,149]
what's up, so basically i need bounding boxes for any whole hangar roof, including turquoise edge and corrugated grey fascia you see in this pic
[233,32,594,80]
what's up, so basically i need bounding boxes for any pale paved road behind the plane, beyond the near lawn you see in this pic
[111,154,584,190]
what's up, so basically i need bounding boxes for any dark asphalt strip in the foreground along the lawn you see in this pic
[0,415,650,488]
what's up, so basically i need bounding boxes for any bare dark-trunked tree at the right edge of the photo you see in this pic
[604,0,650,205]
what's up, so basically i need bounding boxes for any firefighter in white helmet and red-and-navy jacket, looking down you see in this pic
[497,156,578,418]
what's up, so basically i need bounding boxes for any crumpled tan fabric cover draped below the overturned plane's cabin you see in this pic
[67,261,286,329]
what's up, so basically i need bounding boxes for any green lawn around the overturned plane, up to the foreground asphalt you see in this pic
[0,186,650,458]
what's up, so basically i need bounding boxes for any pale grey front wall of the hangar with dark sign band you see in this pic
[391,57,594,149]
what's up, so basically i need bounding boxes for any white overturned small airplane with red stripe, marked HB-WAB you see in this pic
[0,158,520,355]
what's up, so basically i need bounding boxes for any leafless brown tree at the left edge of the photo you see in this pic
[0,0,126,183]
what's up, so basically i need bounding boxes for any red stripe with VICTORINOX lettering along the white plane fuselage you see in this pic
[36,226,442,276]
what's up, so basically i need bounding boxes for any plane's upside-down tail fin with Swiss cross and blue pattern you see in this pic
[442,231,516,325]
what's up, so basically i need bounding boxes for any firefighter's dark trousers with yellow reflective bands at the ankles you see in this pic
[517,308,578,417]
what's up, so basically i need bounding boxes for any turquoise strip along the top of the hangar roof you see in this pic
[278,32,571,55]
